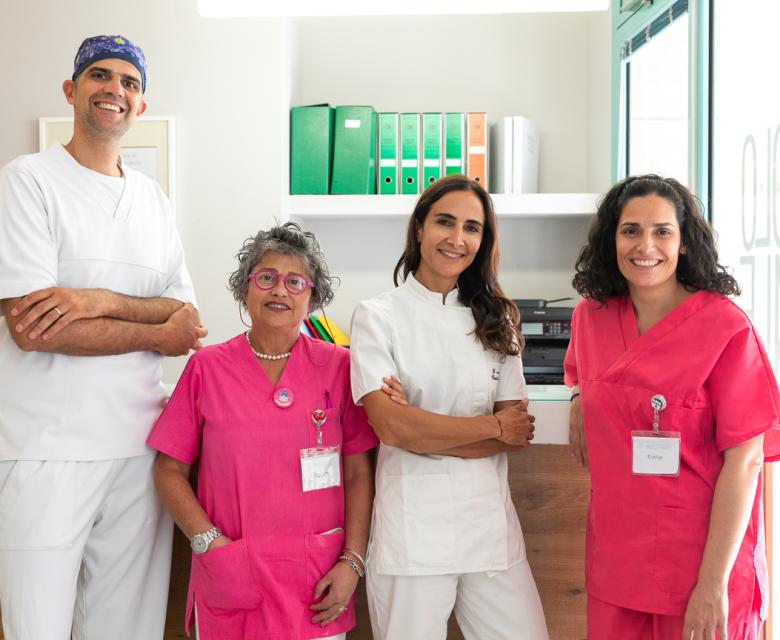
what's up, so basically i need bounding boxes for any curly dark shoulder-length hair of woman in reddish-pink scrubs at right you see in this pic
[572,174,740,302]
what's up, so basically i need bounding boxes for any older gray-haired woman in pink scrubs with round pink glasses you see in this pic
[148,223,377,640]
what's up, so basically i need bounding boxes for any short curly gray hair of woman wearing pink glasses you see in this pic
[228,222,338,312]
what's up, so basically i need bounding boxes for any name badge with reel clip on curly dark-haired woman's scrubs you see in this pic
[631,394,680,476]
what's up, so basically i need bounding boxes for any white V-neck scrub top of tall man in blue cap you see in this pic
[0,144,194,460]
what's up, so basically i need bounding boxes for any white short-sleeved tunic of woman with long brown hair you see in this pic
[350,276,526,575]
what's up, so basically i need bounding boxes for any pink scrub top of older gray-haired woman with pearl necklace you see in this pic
[148,334,378,640]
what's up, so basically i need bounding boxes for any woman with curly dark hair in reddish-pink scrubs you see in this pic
[565,175,780,640]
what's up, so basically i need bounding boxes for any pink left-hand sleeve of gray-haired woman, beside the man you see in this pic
[146,356,203,464]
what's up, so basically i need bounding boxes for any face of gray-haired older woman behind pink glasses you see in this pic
[245,251,311,334]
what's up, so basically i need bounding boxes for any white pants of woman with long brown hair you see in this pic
[366,560,549,640]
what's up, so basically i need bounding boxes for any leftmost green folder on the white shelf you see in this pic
[290,104,334,194]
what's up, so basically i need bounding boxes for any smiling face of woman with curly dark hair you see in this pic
[615,194,685,295]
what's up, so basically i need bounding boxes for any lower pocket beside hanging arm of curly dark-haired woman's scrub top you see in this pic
[654,507,710,601]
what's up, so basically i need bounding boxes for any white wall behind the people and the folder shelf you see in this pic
[0,0,611,380]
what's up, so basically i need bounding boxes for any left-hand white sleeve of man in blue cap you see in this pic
[0,167,58,299]
